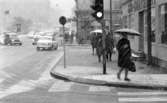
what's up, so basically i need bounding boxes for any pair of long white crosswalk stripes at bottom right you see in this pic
[117,91,167,103]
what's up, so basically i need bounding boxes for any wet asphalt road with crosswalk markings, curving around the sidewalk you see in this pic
[0,37,167,103]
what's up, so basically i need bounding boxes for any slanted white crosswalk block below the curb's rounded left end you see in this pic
[48,80,74,92]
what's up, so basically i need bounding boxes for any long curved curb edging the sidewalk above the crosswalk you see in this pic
[50,71,167,90]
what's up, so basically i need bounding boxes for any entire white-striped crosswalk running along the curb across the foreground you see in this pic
[0,76,167,103]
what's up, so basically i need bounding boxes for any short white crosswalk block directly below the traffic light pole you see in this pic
[89,86,111,92]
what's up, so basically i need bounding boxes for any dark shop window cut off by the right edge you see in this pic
[160,4,167,44]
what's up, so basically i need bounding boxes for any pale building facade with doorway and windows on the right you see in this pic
[122,0,167,67]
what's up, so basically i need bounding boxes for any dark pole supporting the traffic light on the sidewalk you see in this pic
[101,20,106,74]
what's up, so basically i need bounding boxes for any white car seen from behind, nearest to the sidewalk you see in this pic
[36,36,58,51]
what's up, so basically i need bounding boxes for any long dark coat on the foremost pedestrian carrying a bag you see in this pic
[116,38,131,68]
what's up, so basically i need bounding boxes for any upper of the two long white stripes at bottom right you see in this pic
[117,92,167,96]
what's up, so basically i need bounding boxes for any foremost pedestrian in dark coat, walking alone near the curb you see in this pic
[116,34,131,81]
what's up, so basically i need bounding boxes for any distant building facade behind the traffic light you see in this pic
[76,0,121,42]
